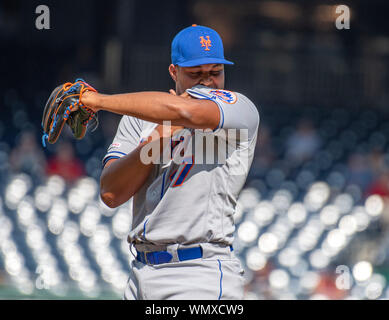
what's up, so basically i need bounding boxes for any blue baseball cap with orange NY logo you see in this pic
[172,24,234,67]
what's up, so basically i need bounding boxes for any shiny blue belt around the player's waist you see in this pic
[136,246,233,264]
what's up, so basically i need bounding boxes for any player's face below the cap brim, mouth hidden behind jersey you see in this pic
[169,64,224,94]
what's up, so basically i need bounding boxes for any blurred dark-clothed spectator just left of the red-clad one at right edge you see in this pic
[347,153,373,192]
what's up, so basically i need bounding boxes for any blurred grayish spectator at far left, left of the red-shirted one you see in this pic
[9,131,46,180]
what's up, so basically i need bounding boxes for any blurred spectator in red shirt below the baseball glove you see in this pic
[46,141,85,184]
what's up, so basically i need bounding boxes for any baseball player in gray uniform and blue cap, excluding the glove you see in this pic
[81,25,259,300]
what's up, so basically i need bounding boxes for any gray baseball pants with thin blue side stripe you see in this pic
[123,243,244,300]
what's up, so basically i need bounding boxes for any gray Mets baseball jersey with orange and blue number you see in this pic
[103,86,259,245]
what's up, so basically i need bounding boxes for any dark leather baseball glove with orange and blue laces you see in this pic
[42,79,98,147]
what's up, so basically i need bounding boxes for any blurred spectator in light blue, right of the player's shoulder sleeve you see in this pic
[286,119,321,164]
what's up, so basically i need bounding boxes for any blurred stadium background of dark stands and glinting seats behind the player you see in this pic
[0,0,389,299]
